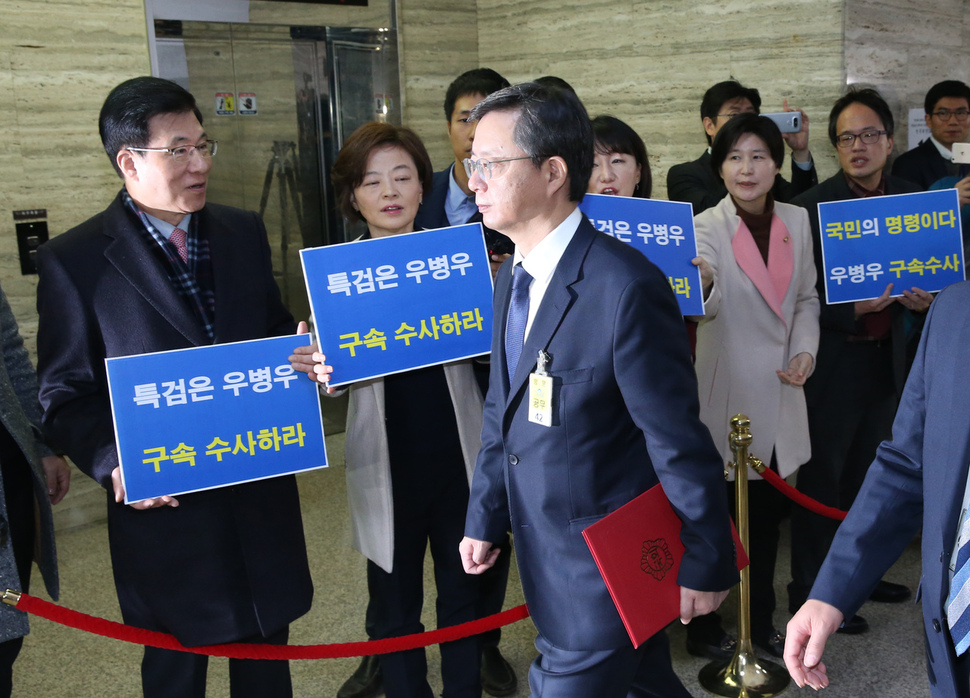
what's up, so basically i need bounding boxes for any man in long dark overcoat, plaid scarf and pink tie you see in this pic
[37,77,313,697]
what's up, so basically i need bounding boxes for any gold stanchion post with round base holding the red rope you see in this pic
[698,414,791,698]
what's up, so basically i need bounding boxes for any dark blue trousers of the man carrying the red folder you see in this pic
[529,632,690,698]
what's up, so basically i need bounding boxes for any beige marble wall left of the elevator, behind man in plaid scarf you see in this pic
[0,0,150,351]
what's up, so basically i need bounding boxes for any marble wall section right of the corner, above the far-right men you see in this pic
[845,0,970,153]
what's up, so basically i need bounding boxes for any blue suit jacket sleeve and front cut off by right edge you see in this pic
[811,282,970,698]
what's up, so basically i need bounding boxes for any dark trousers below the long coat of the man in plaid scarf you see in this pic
[141,627,293,698]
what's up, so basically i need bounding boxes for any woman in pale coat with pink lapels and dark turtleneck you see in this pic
[688,114,819,657]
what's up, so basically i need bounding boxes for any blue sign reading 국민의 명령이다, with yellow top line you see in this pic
[818,189,964,303]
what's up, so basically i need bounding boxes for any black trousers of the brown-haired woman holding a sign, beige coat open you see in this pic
[367,456,482,698]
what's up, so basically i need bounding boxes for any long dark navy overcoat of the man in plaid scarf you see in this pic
[37,189,313,645]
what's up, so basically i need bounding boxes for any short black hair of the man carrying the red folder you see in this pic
[471,82,593,202]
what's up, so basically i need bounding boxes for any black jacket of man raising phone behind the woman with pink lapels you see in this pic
[667,150,818,216]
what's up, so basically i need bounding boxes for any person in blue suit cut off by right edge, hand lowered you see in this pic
[785,282,970,698]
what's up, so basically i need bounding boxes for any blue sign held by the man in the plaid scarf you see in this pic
[105,335,327,503]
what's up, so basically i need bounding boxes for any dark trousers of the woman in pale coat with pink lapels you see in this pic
[687,474,789,642]
